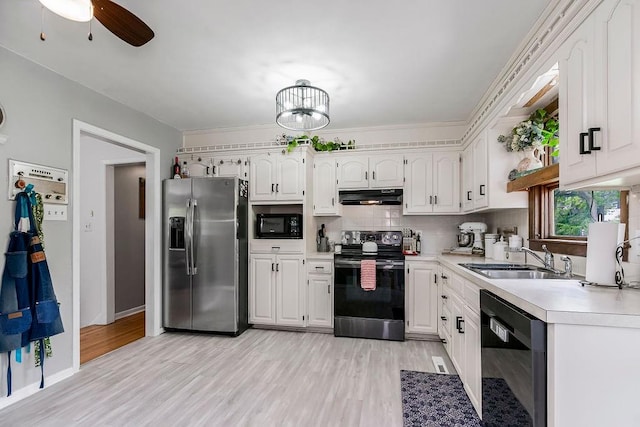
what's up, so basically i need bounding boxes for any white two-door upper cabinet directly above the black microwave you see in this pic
[249,152,305,202]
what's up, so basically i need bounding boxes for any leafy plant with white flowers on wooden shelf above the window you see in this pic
[498,108,559,157]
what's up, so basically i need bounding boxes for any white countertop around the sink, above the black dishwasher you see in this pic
[438,255,640,328]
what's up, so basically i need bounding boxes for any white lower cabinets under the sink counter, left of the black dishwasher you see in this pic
[438,268,482,415]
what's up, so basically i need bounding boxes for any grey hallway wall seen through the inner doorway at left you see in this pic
[113,165,146,317]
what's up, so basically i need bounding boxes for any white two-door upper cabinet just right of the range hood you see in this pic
[402,151,460,215]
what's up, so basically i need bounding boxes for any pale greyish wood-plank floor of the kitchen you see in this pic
[0,329,455,427]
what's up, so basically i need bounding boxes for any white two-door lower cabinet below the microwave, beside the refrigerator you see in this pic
[249,254,306,326]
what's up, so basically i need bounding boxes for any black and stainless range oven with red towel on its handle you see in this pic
[334,231,405,341]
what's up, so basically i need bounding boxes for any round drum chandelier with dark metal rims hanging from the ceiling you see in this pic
[276,80,329,131]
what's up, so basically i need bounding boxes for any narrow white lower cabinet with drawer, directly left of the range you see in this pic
[307,259,333,328]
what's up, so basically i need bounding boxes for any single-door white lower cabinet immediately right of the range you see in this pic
[405,261,438,334]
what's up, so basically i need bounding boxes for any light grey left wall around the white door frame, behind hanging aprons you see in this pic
[0,47,182,398]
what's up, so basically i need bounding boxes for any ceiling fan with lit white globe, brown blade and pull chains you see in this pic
[40,0,155,47]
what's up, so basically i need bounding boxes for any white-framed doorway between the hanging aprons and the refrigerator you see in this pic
[73,120,162,370]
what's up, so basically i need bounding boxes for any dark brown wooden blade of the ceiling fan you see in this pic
[91,0,155,47]
